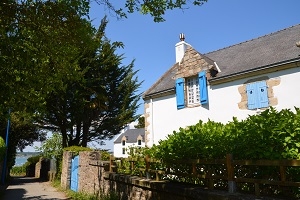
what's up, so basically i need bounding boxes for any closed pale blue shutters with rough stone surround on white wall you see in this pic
[246,81,269,110]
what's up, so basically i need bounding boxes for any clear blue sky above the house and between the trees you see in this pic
[25,0,300,151]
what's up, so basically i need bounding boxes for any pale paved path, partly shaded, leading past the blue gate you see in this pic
[2,177,68,200]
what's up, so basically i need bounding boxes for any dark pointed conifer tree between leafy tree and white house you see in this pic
[36,18,141,147]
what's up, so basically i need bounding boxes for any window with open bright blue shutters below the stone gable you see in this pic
[176,71,208,109]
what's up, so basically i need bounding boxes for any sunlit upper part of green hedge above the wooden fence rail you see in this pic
[151,108,300,159]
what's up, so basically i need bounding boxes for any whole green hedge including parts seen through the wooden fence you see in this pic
[148,107,300,196]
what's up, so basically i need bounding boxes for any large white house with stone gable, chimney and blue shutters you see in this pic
[143,25,300,146]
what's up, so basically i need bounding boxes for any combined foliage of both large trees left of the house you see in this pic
[0,0,140,150]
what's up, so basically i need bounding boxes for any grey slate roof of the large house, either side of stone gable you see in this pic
[143,24,300,98]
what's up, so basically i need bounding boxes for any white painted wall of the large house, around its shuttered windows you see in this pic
[145,67,300,146]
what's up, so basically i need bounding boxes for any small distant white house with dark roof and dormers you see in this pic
[114,128,145,158]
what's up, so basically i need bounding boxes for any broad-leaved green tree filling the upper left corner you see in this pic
[0,0,90,114]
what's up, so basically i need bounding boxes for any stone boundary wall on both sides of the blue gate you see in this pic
[61,151,286,200]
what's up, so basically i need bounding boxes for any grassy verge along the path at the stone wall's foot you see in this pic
[52,180,118,200]
